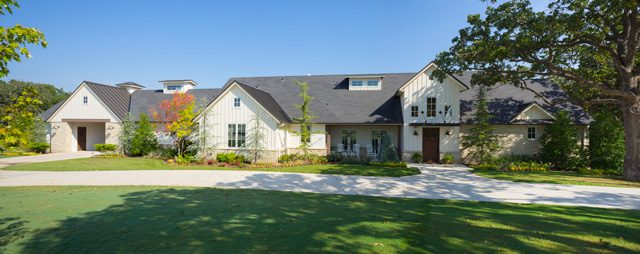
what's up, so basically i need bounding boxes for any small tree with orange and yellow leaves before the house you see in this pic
[152,93,196,156]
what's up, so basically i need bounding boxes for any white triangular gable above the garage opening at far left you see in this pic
[47,83,119,122]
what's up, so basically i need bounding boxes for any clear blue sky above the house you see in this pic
[0,0,548,90]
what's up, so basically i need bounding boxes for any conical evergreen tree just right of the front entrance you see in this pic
[462,86,500,164]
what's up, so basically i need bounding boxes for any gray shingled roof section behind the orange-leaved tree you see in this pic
[129,88,222,119]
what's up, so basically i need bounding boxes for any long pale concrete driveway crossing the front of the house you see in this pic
[0,165,640,210]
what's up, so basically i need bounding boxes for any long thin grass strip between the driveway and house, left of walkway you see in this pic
[3,158,420,177]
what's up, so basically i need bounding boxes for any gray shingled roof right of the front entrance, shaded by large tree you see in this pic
[458,73,593,124]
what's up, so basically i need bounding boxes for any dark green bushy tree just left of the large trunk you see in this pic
[589,112,624,169]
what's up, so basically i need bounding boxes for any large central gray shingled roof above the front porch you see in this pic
[225,73,415,124]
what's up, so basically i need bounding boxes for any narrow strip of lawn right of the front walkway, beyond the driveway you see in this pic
[471,170,640,188]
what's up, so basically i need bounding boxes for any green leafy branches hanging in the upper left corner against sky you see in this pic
[0,0,47,77]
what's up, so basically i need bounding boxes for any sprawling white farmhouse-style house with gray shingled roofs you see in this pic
[42,63,592,162]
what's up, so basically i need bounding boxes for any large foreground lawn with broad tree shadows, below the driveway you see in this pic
[0,186,640,253]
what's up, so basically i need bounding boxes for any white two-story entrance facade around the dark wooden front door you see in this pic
[400,65,464,157]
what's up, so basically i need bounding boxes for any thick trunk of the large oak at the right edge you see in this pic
[622,101,640,181]
